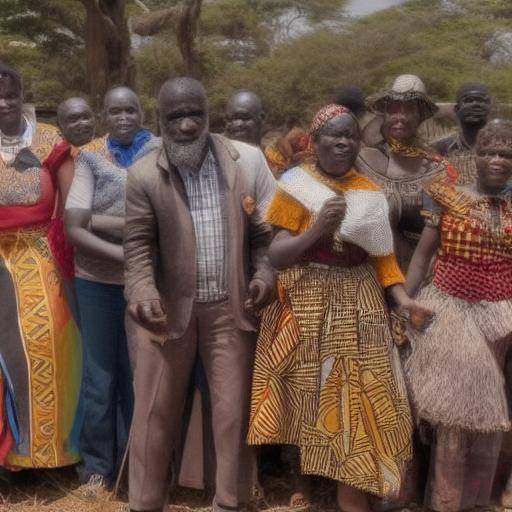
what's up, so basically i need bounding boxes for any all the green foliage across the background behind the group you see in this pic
[0,0,512,130]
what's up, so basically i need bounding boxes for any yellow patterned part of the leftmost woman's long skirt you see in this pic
[0,229,82,468]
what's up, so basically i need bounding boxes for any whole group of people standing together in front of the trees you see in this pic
[0,57,512,512]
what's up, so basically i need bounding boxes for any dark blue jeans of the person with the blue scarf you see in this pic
[75,278,133,483]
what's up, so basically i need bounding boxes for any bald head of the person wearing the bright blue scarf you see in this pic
[103,86,142,145]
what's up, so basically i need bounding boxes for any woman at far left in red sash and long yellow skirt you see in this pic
[0,64,82,469]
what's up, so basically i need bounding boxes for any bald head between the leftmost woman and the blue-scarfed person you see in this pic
[57,97,95,146]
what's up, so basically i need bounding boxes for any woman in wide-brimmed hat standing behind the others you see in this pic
[356,75,453,272]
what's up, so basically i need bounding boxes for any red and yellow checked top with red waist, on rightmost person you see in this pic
[429,180,512,302]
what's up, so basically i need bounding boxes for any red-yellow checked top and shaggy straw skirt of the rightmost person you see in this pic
[406,180,512,432]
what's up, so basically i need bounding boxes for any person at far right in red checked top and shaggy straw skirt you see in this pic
[405,122,512,512]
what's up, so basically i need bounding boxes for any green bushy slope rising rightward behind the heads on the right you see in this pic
[203,0,512,125]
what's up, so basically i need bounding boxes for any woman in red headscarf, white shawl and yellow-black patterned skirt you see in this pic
[248,105,430,512]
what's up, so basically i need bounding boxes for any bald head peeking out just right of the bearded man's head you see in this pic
[226,90,265,146]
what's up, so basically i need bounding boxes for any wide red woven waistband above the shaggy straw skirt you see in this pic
[434,256,512,302]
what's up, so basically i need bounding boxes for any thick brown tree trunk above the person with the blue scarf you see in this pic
[81,0,135,107]
